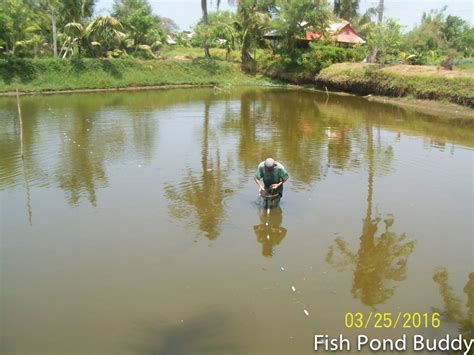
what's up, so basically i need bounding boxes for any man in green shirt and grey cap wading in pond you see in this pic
[254,158,288,206]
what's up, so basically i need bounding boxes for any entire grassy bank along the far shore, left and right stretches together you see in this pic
[0,55,474,116]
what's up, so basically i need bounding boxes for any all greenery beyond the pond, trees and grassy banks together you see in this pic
[0,0,474,107]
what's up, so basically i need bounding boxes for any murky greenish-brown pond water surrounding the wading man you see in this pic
[0,88,474,354]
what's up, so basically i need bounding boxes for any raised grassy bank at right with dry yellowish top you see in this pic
[316,63,474,108]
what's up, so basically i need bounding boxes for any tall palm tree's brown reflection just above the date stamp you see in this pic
[326,122,415,307]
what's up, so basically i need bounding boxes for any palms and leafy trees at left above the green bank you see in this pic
[0,0,177,58]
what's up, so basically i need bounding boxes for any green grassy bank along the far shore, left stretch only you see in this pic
[0,58,270,92]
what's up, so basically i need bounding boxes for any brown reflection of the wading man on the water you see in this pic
[253,206,287,257]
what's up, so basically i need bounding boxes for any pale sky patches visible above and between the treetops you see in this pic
[95,0,474,30]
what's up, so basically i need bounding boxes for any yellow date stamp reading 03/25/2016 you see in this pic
[344,312,441,329]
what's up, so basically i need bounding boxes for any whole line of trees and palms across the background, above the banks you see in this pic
[0,0,474,71]
